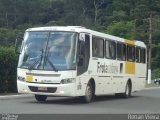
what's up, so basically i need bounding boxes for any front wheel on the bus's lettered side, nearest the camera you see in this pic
[82,82,94,103]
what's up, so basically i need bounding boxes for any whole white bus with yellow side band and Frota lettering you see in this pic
[17,26,147,102]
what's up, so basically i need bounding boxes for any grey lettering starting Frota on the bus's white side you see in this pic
[97,62,118,73]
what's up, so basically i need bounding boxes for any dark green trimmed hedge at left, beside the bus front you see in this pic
[0,47,17,93]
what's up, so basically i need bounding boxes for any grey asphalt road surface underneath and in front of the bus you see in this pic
[0,88,160,119]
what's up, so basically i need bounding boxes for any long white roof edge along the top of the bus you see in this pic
[26,26,146,48]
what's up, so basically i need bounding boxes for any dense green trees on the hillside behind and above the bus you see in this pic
[0,0,160,46]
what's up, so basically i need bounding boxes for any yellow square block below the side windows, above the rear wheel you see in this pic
[125,61,135,74]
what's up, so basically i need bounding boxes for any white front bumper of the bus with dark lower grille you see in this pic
[17,80,79,96]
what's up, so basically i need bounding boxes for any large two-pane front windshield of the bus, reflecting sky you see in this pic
[18,31,78,71]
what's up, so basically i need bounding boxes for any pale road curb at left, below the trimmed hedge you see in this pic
[0,94,33,100]
